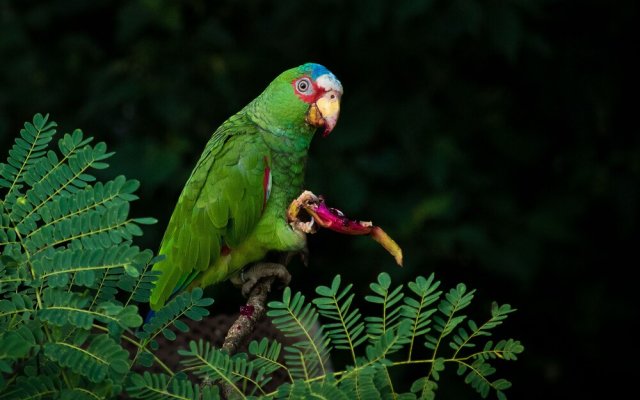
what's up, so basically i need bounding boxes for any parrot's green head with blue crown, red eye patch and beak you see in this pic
[261,63,342,136]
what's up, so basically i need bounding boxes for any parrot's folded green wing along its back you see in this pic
[149,114,270,309]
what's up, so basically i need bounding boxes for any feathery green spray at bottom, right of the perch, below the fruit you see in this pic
[165,273,524,399]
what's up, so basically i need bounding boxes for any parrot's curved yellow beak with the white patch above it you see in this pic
[306,75,342,136]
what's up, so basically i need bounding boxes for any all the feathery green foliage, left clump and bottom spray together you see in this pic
[0,114,524,399]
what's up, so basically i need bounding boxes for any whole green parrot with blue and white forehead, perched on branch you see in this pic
[149,63,342,310]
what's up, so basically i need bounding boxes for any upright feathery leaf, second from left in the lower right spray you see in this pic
[313,275,366,364]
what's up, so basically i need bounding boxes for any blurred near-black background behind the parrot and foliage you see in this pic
[0,0,640,399]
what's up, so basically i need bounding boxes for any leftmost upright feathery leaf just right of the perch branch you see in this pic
[267,287,330,379]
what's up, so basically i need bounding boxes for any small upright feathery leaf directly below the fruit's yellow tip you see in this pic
[365,272,404,342]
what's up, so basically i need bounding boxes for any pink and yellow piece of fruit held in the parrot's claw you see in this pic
[287,190,402,266]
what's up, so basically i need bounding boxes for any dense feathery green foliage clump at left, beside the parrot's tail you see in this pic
[0,114,213,399]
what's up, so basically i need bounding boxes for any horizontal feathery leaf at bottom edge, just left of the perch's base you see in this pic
[127,372,220,400]
